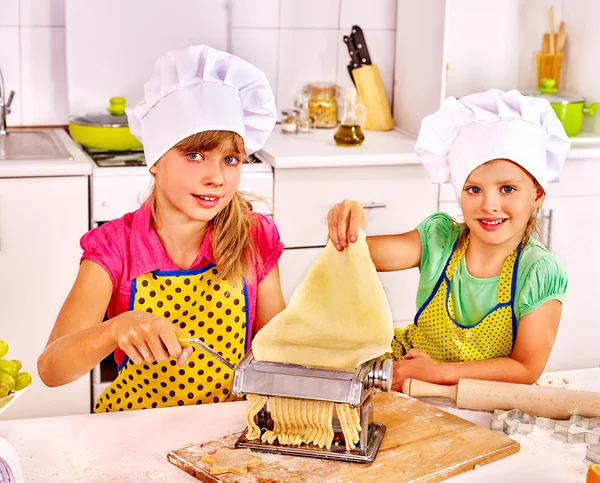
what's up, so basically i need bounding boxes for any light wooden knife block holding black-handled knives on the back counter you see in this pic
[352,64,394,131]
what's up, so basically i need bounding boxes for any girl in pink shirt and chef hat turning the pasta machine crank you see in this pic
[38,46,284,412]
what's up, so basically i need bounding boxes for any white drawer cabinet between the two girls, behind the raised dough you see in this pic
[273,164,437,325]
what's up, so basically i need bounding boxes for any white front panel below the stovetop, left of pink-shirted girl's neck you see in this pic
[91,174,152,223]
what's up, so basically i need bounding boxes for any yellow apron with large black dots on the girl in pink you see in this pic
[94,264,251,412]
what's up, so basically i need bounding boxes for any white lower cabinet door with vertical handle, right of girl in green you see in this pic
[543,196,600,371]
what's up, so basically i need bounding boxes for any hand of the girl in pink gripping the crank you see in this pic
[110,310,193,367]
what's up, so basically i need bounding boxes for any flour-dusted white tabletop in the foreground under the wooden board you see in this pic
[0,368,600,483]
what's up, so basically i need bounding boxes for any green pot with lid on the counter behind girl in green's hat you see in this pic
[523,79,600,137]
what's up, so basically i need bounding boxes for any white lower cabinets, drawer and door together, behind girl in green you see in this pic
[438,159,600,371]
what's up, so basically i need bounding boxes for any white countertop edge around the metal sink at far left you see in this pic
[0,129,92,178]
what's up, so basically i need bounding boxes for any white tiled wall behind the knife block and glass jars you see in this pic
[232,0,396,120]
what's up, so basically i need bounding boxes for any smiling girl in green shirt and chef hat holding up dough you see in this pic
[328,90,570,389]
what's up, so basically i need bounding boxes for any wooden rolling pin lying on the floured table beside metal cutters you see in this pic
[402,379,600,419]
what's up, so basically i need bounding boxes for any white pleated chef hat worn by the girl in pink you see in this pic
[126,45,277,168]
